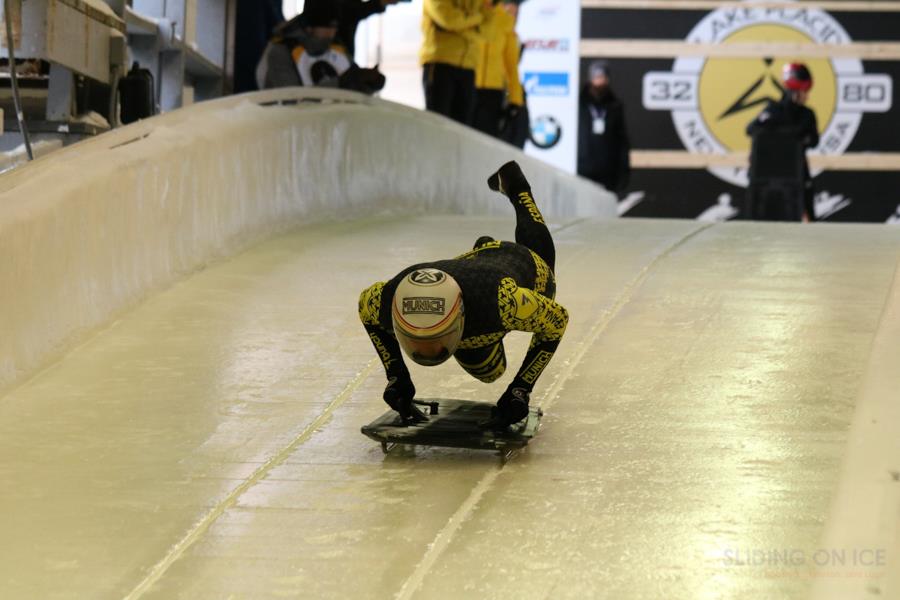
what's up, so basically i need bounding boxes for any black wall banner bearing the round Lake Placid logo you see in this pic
[581,4,900,223]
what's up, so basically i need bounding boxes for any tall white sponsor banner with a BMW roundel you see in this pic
[516,0,581,173]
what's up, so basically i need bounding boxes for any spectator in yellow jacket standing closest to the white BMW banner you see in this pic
[474,0,525,137]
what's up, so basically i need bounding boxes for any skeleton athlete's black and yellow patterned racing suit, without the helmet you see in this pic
[359,178,569,392]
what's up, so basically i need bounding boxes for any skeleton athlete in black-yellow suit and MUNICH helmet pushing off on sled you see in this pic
[359,162,569,428]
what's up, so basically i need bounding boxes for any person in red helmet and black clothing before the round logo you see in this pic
[747,63,819,223]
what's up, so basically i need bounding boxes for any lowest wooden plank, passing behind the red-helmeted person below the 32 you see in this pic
[631,150,900,171]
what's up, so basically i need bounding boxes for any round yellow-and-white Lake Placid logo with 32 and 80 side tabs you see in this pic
[642,2,893,187]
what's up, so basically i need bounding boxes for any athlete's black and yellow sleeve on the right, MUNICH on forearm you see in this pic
[499,278,569,390]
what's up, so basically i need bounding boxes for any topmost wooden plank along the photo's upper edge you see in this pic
[581,0,900,12]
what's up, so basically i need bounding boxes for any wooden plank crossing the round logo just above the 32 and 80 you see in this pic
[581,39,900,60]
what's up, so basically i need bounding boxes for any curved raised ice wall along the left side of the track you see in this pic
[0,88,616,389]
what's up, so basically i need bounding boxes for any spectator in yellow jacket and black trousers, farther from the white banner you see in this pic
[419,0,494,125]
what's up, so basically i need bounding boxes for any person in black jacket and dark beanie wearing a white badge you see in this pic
[578,60,631,192]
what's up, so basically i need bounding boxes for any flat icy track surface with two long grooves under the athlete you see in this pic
[0,217,900,599]
